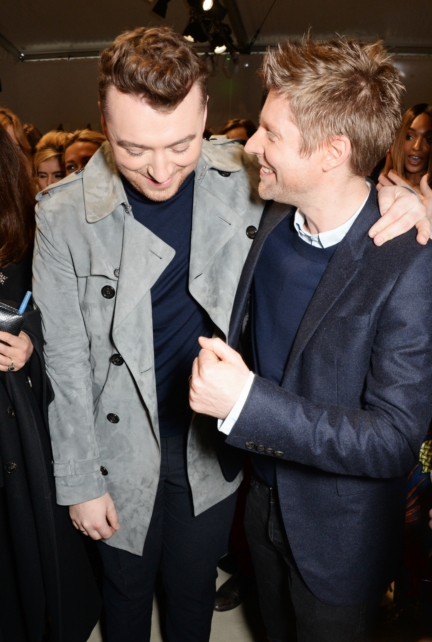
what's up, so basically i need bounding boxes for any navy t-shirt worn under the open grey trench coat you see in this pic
[122,172,214,437]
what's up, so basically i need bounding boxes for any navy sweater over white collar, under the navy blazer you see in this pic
[251,216,338,486]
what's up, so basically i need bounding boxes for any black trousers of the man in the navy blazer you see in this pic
[245,478,380,642]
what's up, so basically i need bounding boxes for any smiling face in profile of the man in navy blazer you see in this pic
[245,91,322,207]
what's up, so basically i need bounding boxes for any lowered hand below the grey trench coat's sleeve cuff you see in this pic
[69,493,120,539]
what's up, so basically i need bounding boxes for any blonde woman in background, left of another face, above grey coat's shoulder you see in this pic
[33,131,72,190]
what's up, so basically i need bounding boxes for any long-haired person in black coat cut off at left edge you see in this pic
[0,122,100,642]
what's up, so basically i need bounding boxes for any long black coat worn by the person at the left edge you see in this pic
[0,311,101,642]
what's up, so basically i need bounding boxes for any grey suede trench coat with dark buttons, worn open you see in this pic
[33,141,263,555]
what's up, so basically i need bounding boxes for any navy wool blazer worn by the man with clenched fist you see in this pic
[227,188,432,605]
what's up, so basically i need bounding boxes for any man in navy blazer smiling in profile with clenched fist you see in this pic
[190,39,432,642]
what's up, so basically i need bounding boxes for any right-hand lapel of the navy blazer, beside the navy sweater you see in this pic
[281,187,379,386]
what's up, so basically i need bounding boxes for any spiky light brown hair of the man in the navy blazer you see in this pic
[262,38,405,176]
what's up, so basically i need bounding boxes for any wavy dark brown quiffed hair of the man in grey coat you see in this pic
[99,27,208,111]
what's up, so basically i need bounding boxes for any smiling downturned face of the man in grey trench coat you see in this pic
[102,84,207,201]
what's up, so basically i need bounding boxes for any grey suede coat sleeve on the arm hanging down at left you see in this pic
[33,202,106,505]
